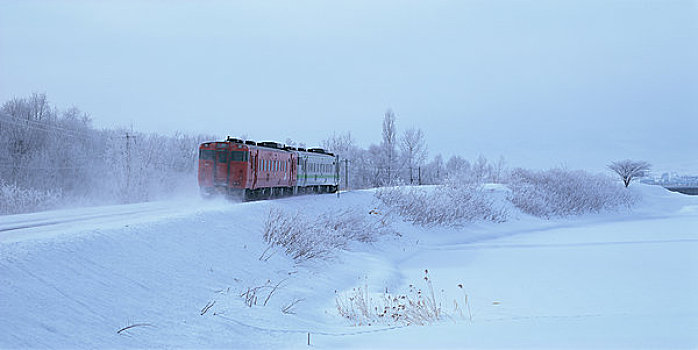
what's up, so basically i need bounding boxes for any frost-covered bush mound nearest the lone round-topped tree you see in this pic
[510,169,636,218]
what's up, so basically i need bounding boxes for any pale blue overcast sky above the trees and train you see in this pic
[0,0,698,171]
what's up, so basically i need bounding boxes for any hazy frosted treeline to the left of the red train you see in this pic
[0,93,211,214]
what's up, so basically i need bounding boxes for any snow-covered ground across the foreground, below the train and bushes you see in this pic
[0,185,698,348]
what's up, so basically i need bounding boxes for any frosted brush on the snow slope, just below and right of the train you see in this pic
[260,208,394,261]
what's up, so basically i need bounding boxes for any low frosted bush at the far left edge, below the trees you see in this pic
[0,179,61,215]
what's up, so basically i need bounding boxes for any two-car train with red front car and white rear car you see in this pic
[198,136,340,201]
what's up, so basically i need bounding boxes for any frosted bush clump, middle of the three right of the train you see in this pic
[376,182,507,226]
